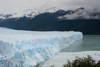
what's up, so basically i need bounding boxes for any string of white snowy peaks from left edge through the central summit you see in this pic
[0,7,59,20]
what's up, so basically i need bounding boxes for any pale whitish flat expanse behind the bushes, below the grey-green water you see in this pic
[41,51,100,67]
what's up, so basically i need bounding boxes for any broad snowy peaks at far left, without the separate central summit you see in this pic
[0,9,39,19]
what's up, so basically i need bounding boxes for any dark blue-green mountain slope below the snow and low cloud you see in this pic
[0,7,100,35]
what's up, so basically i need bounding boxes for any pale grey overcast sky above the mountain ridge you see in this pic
[0,0,100,14]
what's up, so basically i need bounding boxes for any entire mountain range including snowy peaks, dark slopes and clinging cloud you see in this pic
[0,7,100,35]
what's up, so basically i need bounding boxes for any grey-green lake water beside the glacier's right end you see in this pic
[61,35,100,52]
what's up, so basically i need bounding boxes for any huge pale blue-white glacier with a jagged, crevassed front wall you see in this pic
[0,29,83,67]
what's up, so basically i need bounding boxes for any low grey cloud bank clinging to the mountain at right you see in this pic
[58,9,100,20]
